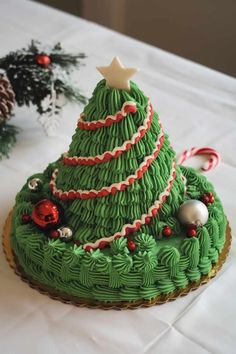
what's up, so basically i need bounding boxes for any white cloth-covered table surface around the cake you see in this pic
[0,0,236,354]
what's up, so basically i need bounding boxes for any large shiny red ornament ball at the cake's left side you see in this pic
[31,199,60,229]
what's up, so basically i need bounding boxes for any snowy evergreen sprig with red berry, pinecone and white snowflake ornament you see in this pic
[0,40,87,159]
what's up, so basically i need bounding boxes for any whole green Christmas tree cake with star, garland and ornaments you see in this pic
[7,58,230,306]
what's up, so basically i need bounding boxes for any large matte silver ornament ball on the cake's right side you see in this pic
[178,199,209,226]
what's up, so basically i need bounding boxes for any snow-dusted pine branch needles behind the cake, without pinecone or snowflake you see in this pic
[0,41,86,114]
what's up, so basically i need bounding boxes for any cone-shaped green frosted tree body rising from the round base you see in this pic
[53,80,184,244]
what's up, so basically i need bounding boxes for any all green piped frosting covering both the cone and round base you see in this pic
[11,80,229,302]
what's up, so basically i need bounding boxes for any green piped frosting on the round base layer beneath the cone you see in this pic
[11,167,226,302]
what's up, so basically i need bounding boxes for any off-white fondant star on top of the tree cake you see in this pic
[97,57,138,91]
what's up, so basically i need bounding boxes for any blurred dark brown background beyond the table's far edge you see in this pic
[37,0,236,76]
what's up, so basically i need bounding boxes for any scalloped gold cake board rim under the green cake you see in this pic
[3,212,232,310]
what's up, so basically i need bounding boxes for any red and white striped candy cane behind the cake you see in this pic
[178,147,220,171]
